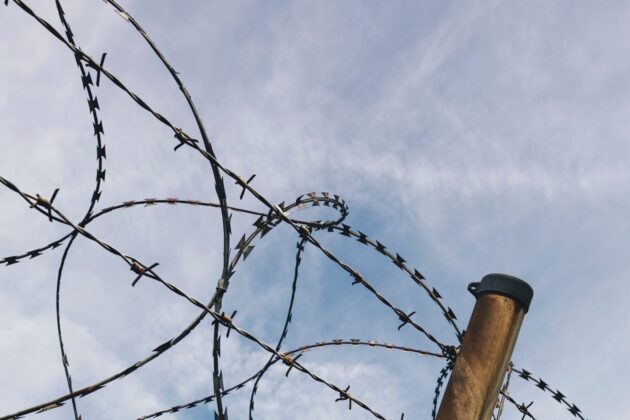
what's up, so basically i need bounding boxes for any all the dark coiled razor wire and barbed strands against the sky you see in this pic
[0,0,584,420]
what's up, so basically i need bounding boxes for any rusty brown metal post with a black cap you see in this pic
[436,274,534,420]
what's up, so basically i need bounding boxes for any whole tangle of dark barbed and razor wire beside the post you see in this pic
[0,0,583,420]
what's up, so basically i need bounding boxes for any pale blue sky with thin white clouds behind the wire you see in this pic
[0,0,630,420]
